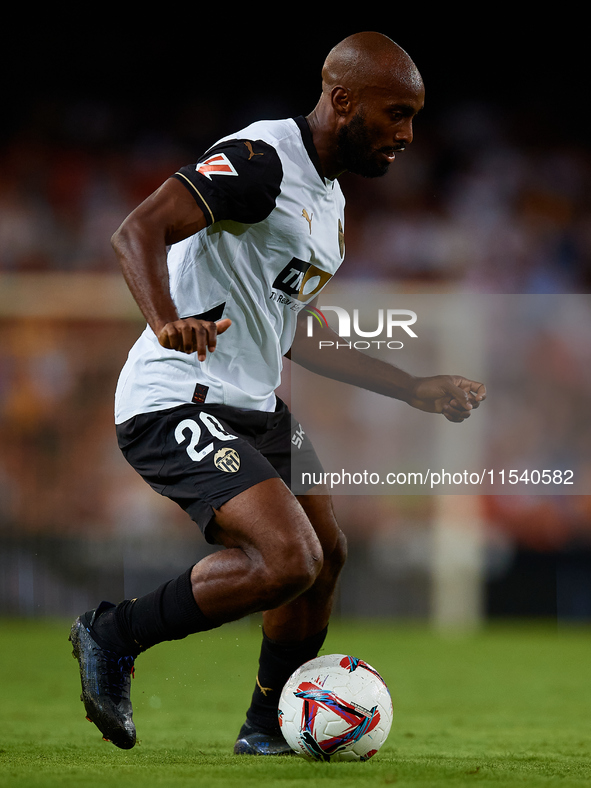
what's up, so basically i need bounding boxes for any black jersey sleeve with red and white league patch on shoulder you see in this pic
[173,140,283,225]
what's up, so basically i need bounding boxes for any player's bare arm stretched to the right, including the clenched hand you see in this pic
[287,314,486,423]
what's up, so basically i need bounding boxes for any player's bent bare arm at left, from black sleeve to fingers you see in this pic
[111,178,231,361]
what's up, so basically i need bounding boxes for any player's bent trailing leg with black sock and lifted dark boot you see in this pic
[71,478,323,748]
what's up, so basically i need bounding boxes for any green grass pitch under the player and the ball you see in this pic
[0,620,591,788]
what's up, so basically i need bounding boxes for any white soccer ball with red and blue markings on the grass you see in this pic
[279,654,392,761]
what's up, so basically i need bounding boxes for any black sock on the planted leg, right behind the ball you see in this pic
[246,627,328,732]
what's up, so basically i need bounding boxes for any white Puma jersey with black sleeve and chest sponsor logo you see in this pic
[115,117,345,424]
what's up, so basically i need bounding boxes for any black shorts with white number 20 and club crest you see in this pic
[116,399,322,541]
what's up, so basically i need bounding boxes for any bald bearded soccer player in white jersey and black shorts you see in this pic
[70,33,486,755]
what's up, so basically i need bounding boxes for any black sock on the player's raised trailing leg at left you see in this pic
[90,567,217,657]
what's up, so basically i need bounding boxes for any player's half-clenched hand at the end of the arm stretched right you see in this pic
[408,375,486,424]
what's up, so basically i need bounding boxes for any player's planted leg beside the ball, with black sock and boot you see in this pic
[234,486,346,755]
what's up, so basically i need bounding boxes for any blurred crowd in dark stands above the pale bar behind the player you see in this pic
[0,97,591,293]
